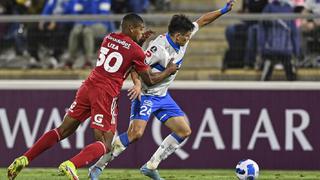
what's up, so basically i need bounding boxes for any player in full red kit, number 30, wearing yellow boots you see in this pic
[8,14,177,180]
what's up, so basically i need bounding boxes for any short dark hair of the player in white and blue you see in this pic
[168,14,194,35]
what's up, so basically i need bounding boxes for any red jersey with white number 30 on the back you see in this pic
[85,33,149,97]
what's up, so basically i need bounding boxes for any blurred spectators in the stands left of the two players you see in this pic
[0,0,170,68]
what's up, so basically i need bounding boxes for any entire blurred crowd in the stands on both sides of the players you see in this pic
[0,0,320,80]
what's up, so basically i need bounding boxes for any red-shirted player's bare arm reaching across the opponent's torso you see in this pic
[138,59,178,86]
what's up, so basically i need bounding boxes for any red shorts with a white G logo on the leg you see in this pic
[67,84,119,133]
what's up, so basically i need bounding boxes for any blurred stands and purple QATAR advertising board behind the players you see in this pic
[0,0,320,179]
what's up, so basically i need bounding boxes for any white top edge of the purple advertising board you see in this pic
[0,80,320,90]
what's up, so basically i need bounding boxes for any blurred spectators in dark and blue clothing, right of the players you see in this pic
[223,0,320,80]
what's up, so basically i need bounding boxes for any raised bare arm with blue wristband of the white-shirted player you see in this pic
[196,0,235,28]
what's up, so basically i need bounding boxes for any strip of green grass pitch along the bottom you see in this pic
[0,168,320,180]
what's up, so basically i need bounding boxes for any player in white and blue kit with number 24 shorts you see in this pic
[89,0,234,180]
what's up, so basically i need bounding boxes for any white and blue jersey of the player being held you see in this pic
[142,22,199,96]
